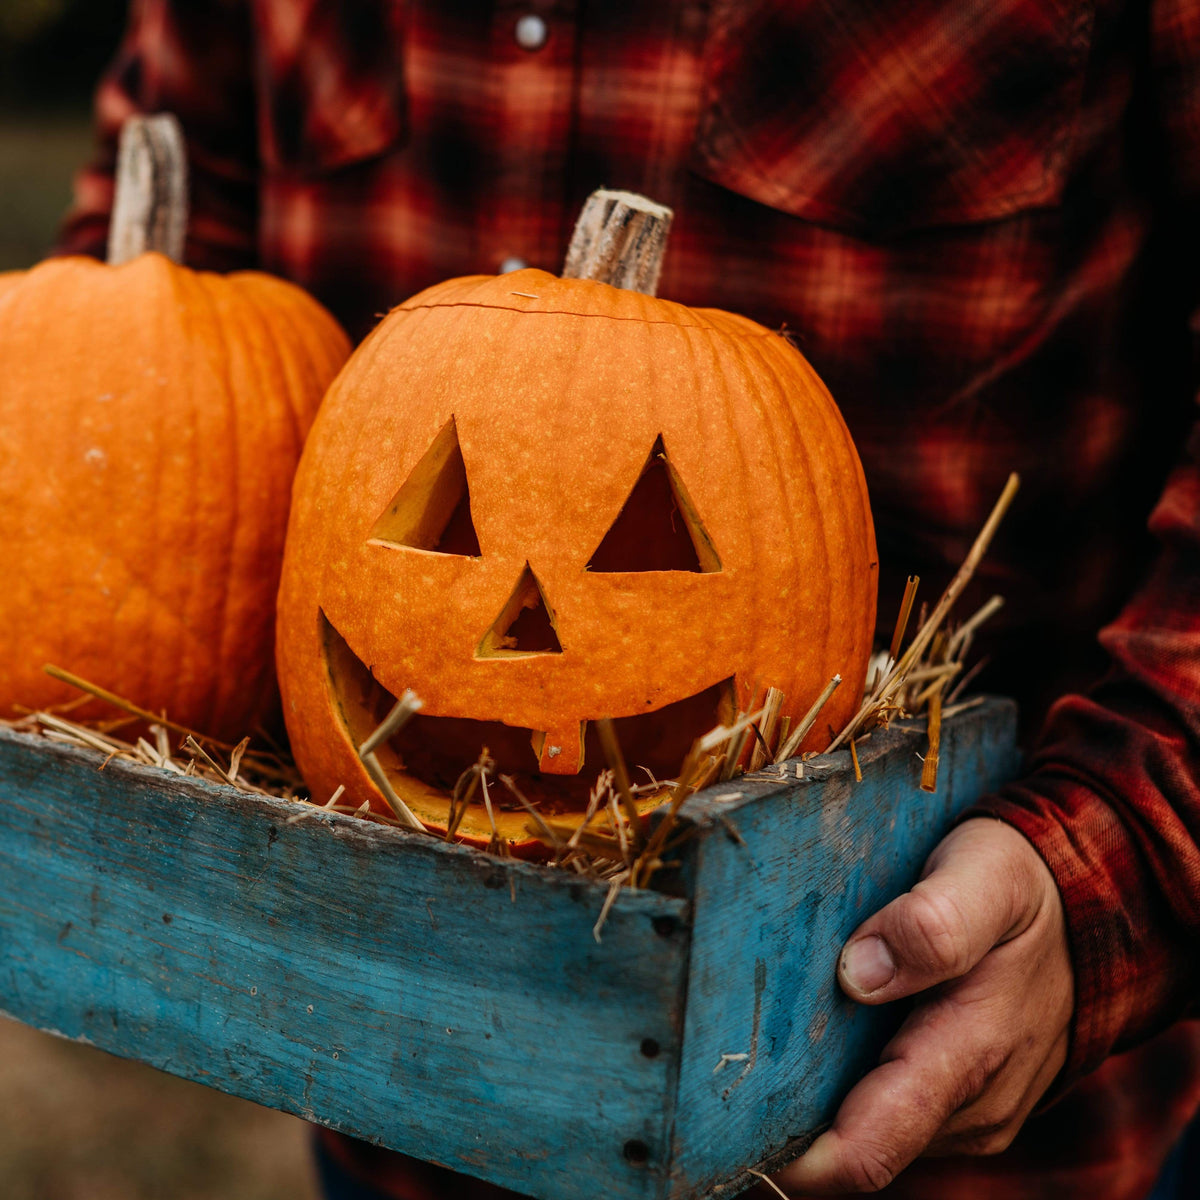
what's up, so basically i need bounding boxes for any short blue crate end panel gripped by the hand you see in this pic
[671,702,1018,1198]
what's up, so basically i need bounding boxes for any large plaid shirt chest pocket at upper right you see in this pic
[691,0,1094,234]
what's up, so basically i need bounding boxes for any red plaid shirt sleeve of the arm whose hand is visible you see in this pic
[969,0,1200,1082]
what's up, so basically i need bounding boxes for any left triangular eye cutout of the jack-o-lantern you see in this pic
[371,416,480,558]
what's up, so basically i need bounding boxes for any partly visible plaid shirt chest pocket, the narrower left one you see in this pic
[253,0,407,175]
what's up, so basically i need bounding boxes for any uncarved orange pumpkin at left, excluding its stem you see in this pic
[0,119,349,739]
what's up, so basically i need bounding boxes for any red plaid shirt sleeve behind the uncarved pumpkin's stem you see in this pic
[55,0,258,271]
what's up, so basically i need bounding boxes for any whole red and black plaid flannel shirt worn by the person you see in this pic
[60,0,1200,1200]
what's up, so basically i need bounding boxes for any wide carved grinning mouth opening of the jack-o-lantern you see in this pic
[319,612,733,841]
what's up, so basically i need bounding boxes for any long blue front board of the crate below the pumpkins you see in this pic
[0,733,688,1200]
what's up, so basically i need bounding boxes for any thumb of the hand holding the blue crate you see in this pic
[838,818,1045,1004]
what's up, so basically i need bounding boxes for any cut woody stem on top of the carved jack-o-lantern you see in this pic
[563,187,674,296]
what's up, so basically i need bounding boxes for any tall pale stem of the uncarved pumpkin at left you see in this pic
[108,113,187,266]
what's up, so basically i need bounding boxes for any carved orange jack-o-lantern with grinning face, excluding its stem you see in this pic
[278,194,875,842]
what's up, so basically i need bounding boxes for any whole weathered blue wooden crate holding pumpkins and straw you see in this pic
[0,700,1016,1200]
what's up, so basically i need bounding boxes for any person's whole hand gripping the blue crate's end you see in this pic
[776,820,1074,1195]
